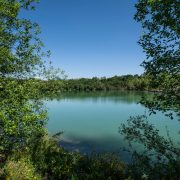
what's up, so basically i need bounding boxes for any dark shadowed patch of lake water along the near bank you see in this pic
[60,135,130,162]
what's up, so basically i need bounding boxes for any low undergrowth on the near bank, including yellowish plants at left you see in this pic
[0,135,127,180]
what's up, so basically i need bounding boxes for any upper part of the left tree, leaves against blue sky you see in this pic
[0,0,47,78]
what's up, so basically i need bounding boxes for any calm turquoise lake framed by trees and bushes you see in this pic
[46,91,179,160]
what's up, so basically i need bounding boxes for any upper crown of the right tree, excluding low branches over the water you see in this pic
[135,0,180,117]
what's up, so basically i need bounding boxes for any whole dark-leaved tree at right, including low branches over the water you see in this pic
[120,0,180,179]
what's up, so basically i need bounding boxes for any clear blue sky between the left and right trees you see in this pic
[25,0,145,78]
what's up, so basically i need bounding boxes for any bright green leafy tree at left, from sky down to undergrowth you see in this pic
[0,0,49,162]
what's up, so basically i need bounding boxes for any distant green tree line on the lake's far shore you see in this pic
[35,75,157,93]
